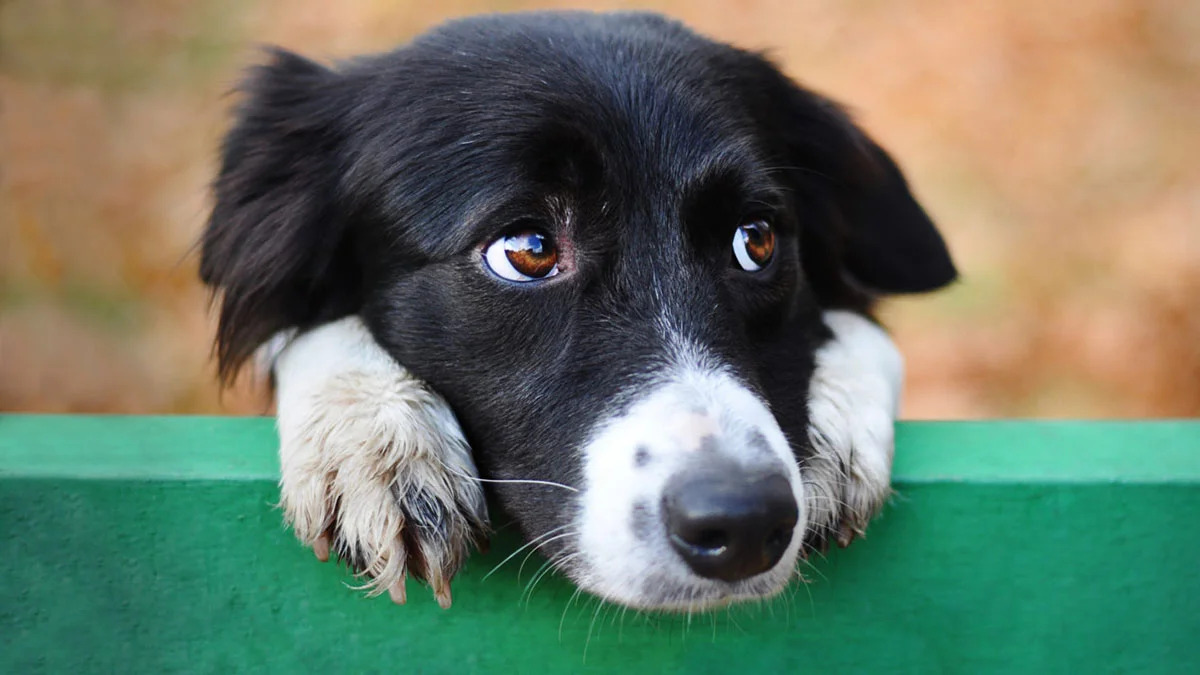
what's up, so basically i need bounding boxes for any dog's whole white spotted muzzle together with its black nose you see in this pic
[571,368,806,609]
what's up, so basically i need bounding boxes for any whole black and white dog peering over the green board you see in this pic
[202,13,955,609]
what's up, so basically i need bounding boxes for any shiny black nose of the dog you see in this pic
[662,466,799,581]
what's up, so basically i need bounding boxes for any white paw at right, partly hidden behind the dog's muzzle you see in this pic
[800,311,904,551]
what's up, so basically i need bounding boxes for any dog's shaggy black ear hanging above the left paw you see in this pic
[200,49,356,382]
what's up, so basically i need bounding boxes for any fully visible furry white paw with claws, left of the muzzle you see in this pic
[275,317,487,608]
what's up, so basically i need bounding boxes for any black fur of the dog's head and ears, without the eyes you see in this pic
[202,13,955,552]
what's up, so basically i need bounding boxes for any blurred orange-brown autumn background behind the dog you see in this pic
[0,0,1200,418]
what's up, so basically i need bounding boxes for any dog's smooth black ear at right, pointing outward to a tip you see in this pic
[772,83,958,294]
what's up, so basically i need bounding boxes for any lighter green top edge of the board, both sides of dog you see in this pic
[0,414,1200,486]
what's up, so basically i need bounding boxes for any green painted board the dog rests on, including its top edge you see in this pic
[0,416,1200,674]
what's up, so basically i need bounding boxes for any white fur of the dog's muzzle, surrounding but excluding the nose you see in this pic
[569,368,805,610]
